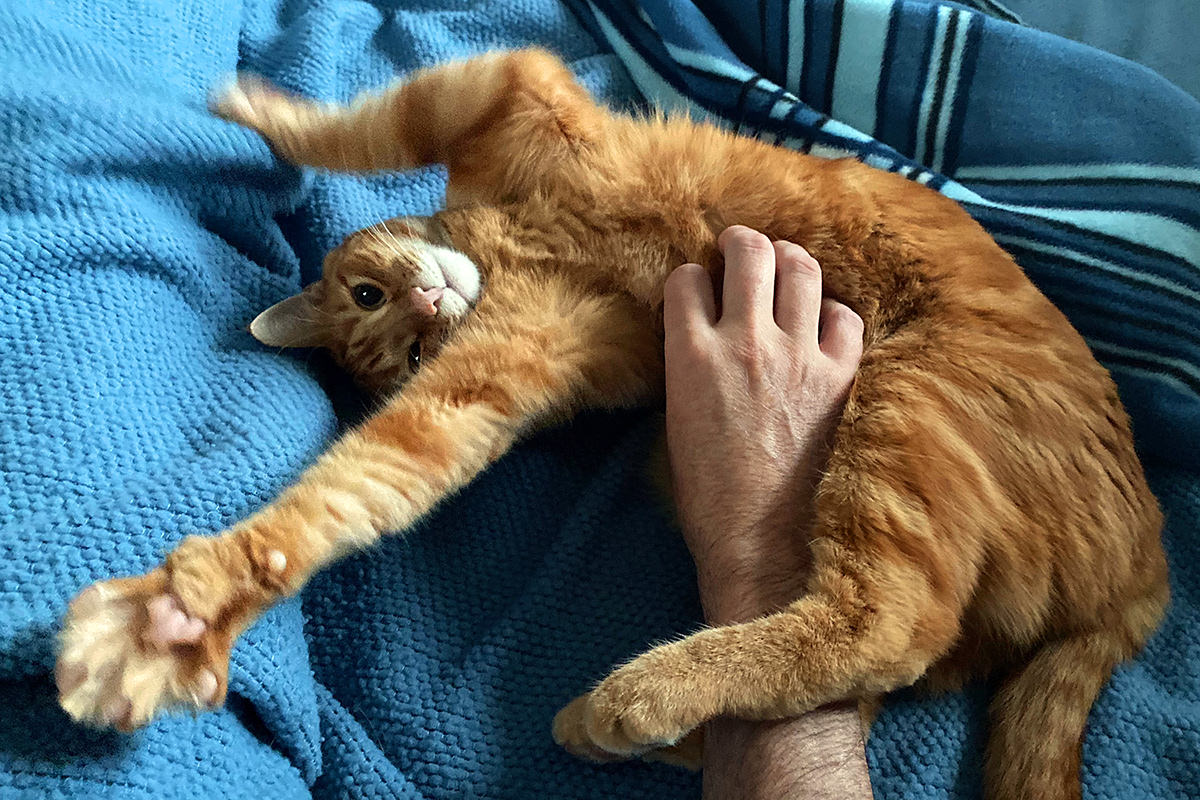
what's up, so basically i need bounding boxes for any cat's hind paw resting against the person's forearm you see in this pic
[553,656,707,763]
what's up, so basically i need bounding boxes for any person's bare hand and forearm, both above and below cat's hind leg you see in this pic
[664,228,871,800]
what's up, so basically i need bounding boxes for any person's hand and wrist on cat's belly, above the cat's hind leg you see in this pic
[664,225,863,624]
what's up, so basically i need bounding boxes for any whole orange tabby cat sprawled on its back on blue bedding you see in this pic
[51,50,1168,800]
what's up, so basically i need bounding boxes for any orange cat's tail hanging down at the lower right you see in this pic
[984,587,1166,800]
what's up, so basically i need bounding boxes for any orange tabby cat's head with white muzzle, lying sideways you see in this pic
[250,218,481,391]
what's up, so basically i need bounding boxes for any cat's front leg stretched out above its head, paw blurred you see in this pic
[210,48,606,197]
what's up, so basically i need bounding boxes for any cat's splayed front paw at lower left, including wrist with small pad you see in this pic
[55,535,278,730]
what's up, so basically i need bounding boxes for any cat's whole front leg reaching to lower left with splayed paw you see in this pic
[55,275,661,729]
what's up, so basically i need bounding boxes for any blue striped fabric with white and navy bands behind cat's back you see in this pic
[576,0,1200,468]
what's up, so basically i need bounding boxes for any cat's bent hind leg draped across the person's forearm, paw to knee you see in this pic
[553,540,958,757]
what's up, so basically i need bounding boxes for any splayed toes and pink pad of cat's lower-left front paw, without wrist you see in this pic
[54,570,228,730]
